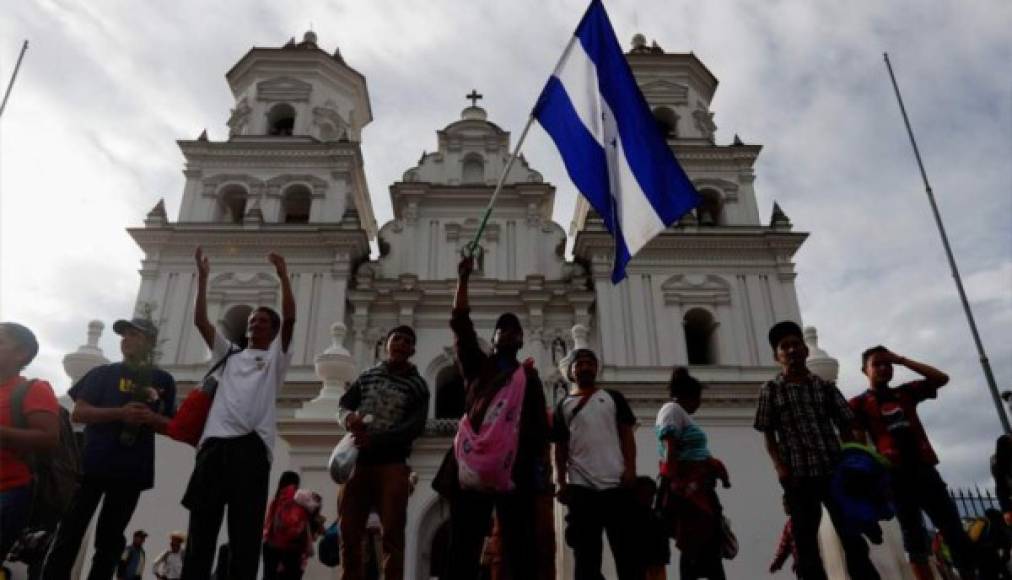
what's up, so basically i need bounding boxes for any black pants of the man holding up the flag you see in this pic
[443,491,537,580]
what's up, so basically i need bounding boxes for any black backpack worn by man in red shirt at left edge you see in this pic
[10,381,81,529]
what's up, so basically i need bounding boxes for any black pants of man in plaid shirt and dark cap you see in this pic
[784,477,879,580]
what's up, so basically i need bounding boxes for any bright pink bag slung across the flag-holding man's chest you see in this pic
[453,363,527,492]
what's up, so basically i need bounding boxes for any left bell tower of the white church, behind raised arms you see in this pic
[130,31,376,384]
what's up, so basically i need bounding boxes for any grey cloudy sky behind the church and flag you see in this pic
[0,0,1012,484]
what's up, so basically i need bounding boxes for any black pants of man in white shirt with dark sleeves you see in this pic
[566,485,644,580]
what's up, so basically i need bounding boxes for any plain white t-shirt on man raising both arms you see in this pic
[200,332,291,459]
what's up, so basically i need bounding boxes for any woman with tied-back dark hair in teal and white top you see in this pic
[656,366,731,580]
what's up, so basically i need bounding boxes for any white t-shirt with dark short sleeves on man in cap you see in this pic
[552,389,636,490]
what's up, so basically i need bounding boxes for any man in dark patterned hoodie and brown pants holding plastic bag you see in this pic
[338,326,429,580]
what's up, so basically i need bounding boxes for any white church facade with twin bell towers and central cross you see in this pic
[61,32,918,580]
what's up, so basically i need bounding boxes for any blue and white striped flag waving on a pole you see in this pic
[533,0,699,283]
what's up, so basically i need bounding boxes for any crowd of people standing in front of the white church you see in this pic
[0,248,1012,580]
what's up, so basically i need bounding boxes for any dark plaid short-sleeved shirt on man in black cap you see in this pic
[755,375,854,477]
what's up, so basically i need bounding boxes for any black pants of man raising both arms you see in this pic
[182,433,270,580]
